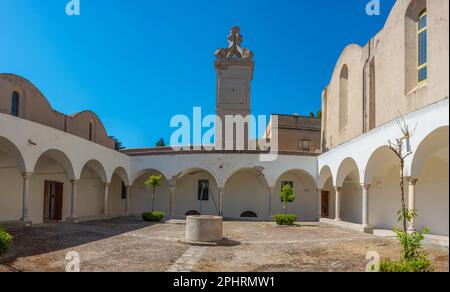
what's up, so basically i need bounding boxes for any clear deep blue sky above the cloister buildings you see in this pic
[0,0,395,147]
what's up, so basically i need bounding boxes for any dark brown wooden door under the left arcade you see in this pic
[44,181,64,223]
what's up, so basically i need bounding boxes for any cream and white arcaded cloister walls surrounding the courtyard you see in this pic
[0,0,449,244]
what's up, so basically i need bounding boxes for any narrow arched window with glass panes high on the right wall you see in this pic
[417,10,428,84]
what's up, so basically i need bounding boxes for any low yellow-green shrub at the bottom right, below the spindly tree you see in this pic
[380,257,434,273]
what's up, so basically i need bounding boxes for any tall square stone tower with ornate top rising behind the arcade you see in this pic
[215,26,255,150]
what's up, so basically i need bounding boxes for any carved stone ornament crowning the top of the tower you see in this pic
[215,26,253,61]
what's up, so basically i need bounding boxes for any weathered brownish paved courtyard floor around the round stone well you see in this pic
[0,218,449,272]
